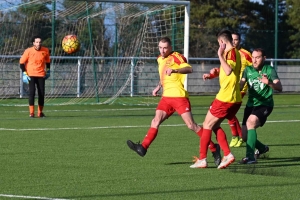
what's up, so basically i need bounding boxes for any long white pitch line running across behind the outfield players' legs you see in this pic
[0,120,300,131]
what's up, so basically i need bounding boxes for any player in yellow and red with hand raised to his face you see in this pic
[192,30,242,169]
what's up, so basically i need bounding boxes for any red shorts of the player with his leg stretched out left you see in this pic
[156,97,191,117]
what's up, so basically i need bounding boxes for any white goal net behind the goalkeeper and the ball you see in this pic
[0,0,188,105]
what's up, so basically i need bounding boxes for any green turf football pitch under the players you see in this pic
[0,94,300,200]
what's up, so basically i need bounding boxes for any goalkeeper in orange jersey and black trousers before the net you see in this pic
[20,36,50,118]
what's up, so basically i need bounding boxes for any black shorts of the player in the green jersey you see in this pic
[242,106,273,126]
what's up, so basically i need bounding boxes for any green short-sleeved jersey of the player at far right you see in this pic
[242,65,279,107]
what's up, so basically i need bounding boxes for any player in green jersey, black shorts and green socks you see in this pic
[240,48,282,164]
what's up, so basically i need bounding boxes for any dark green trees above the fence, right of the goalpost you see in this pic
[190,0,294,58]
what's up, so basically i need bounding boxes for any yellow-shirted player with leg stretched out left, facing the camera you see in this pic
[127,37,221,168]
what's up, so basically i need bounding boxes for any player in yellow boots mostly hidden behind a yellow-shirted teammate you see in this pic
[205,32,252,147]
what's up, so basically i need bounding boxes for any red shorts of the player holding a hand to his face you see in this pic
[209,99,242,119]
